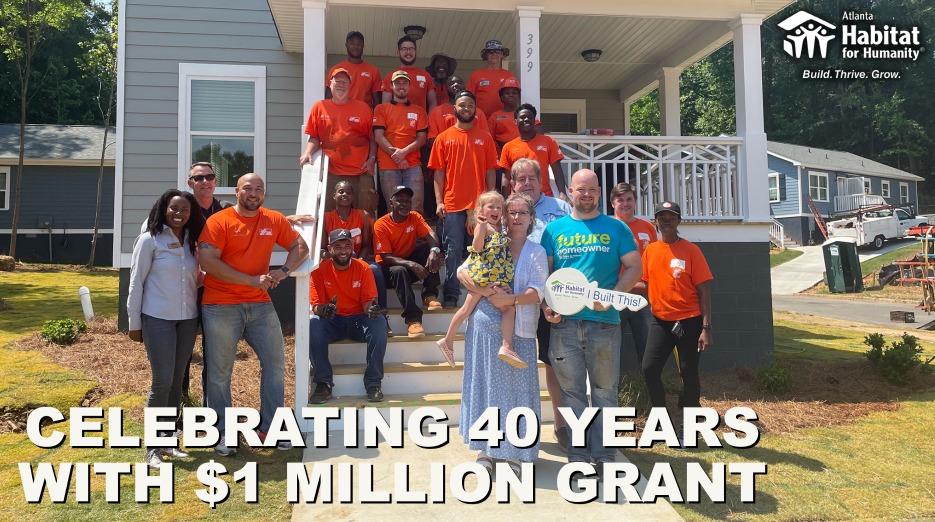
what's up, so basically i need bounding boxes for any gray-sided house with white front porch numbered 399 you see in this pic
[113,0,790,368]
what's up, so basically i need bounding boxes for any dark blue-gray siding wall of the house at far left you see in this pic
[0,165,116,226]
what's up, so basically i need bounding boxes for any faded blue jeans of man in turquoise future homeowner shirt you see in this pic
[549,318,620,462]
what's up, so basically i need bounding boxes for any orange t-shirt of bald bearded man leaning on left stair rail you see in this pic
[198,207,299,304]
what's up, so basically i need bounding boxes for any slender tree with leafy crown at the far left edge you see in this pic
[0,0,84,258]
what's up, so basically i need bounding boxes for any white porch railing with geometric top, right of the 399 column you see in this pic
[551,134,744,220]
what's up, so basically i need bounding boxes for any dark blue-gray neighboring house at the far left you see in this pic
[0,123,116,265]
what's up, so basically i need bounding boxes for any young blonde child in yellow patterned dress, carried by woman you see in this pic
[437,191,527,368]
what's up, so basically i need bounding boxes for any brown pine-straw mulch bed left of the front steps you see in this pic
[16,319,295,420]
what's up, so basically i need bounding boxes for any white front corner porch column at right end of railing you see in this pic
[731,14,769,221]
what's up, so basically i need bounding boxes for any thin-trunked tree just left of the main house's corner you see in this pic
[79,0,117,268]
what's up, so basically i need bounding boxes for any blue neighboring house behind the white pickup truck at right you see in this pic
[767,141,925,245]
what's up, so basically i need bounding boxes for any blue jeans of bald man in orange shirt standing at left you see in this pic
[201,303,285,435]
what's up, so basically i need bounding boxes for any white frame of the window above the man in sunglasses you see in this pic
[178,63,266,194]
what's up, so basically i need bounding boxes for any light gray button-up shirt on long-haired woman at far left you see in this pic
[127,227,198,330]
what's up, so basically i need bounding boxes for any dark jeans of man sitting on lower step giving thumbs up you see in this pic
[308,314,386,390]
